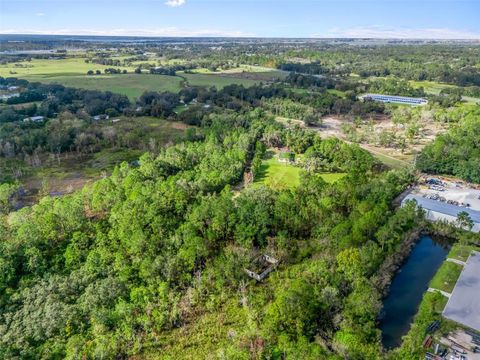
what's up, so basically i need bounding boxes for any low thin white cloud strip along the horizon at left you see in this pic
[0,27,255,37]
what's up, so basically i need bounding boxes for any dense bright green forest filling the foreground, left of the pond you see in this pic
[0,102,428,359]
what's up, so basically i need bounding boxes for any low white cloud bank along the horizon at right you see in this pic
[312,25,480,40]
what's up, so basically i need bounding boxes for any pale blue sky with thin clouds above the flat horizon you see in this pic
[0,0,480,39]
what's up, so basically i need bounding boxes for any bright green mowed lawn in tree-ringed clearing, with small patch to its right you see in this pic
[254,157,345,189]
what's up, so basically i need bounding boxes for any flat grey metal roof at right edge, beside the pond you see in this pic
[443,251,480,331]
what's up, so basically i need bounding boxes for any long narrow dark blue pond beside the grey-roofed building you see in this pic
[380,235,449,349]
